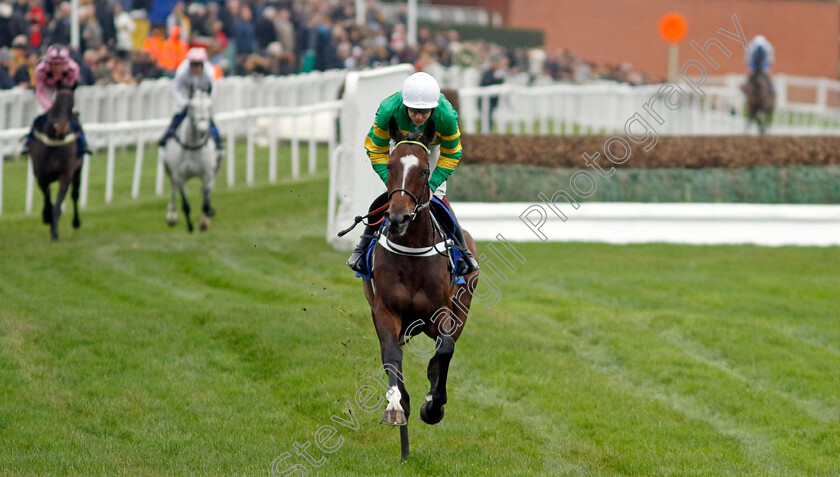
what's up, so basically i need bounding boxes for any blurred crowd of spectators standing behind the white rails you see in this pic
[0,0,660,89]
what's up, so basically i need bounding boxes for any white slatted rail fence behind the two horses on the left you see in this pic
[0,101,341,214]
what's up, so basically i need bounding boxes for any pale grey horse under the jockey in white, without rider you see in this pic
[163,89,221,232]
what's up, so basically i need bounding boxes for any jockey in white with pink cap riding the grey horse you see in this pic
[158,48,224,154]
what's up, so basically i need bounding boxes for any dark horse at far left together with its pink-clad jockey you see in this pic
[23,45,90,240]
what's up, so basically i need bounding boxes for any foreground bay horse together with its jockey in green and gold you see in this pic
[339,73,479,459]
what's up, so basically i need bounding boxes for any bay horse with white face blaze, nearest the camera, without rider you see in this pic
[364,118,478,459]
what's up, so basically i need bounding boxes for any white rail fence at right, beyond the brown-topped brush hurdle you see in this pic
[458,77,840,135]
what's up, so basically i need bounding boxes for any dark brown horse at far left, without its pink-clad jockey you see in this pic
[29,89,82,240]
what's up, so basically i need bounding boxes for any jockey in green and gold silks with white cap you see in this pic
[347,72,478,276]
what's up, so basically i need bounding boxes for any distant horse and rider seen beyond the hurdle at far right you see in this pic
[742,35,776,134]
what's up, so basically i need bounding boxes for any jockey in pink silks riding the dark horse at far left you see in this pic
[23,44,90,157]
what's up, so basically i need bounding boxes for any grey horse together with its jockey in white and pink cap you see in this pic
[159,48,223,232]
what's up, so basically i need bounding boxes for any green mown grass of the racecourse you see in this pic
[0,154,840,476]
